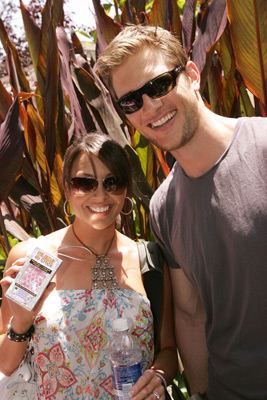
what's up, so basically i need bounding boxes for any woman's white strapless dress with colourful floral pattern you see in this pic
[33,289,154,400]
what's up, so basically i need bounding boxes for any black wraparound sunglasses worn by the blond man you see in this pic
[117,65,185,114]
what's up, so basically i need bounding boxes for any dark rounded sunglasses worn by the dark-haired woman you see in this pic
[70,176,127,196]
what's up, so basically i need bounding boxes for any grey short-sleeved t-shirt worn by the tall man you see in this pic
[150,117,267,400]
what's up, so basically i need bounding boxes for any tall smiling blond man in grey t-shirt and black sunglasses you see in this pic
[97,26,267,400]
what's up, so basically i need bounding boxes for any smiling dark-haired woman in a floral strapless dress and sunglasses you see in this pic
[0,134,177,400]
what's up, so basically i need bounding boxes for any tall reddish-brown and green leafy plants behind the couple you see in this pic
[0,0,267,396]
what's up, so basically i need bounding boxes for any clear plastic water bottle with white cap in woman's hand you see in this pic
[109,318,142,400]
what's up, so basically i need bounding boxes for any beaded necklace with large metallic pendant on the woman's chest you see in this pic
[71,225,120,289]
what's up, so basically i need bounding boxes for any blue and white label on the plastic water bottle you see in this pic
[112,363,142,400]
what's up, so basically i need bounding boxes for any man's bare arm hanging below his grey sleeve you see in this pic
[170,268,208,394]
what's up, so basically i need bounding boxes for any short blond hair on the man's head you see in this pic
[95,25,188,91]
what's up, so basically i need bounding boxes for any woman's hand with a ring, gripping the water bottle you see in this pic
[130,369,165,400]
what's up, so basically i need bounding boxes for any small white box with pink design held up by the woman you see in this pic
[5,247,62,311]
